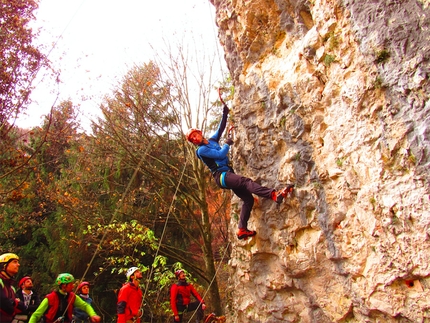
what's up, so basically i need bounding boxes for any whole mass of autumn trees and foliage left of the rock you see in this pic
[0,0,230,322]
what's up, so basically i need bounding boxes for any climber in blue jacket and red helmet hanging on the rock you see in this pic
[186,104,294,239]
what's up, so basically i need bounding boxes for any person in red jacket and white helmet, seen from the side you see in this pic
[116,267,143,323]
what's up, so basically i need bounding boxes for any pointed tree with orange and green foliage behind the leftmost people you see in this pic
[0,101,83,294]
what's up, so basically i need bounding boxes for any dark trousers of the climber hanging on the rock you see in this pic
[213,172,274,229]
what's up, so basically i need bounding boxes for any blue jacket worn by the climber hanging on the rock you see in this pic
[196,110,231,173]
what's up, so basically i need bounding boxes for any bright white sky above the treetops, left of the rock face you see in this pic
[17,0,224,132]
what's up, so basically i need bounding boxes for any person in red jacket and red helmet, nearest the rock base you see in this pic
[170,269,206,323]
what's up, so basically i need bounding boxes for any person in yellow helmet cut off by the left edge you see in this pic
[0,253,26,323]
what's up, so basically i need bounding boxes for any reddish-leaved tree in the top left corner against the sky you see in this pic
[0,0,48,208]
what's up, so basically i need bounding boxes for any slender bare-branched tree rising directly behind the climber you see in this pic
[152,40,230,313]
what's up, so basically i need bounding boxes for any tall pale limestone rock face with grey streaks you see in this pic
[211,0,430,323]
